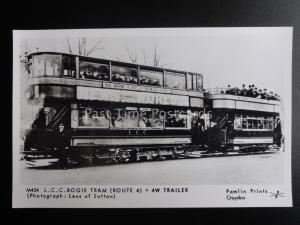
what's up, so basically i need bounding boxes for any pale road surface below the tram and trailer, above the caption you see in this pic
[20,152,286,185]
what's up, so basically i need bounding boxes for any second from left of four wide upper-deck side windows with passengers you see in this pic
[111,64,139,85]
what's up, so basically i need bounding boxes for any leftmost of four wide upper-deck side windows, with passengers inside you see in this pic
[79,60,110,81]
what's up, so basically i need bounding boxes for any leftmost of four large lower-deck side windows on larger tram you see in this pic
[78,107,109,128]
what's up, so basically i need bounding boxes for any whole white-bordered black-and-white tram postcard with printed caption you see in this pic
[13,27,293,208]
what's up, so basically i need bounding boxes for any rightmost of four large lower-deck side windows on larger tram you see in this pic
[165,110,187,128]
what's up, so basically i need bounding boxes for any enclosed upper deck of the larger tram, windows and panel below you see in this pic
[27,52,203,108]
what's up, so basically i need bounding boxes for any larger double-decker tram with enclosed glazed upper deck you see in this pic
[24,52,204,162]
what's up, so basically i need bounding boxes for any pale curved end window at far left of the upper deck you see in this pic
[34,55,60,76]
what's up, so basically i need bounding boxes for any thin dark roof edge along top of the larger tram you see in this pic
[27,51,203,76]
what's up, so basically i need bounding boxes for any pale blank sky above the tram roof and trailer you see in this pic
[22,28,291,95]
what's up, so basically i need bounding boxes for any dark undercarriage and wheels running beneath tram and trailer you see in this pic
[23,142,280,166]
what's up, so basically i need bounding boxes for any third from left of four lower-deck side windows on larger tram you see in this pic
[139,108,164,128]
